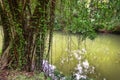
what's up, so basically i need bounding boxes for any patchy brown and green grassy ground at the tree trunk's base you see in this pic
[0,70,51,80]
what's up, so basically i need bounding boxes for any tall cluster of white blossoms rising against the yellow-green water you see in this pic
[61,48,95,80]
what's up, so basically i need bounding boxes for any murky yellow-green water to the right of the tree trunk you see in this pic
[52,33,120,80]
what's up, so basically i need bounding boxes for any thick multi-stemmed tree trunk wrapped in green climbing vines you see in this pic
[0,0,56,71]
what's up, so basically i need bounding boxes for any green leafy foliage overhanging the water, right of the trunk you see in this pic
[55,0,120,39]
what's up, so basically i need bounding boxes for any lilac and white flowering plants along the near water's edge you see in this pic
[42,55,95,80]
